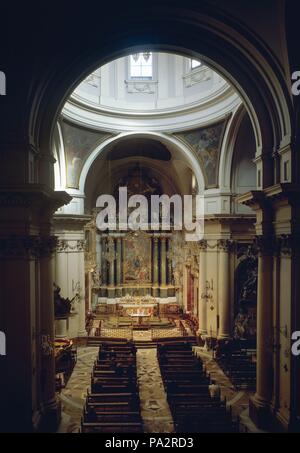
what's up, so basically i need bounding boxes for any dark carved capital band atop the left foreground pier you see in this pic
[0,235,57,258]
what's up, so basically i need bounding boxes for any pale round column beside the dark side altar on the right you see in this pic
[218,239,231,339]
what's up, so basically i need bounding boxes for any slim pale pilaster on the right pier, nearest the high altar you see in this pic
[198,240,207,335]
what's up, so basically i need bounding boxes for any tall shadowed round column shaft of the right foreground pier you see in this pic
[249,236,273,428]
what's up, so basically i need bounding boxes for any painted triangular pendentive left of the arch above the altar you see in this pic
[61,121,111,189]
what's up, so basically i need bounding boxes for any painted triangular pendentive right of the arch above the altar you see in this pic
[176,120,227,188]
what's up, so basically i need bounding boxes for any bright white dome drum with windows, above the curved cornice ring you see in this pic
[71,51,228,114]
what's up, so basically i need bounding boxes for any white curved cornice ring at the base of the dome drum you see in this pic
[62,81,241,134]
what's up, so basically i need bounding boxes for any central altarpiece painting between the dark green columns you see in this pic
[123,233,151,285]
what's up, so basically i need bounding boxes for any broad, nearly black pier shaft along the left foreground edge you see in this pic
[0,240,38,433]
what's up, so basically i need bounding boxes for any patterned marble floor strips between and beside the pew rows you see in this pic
[58,347,262,433]
